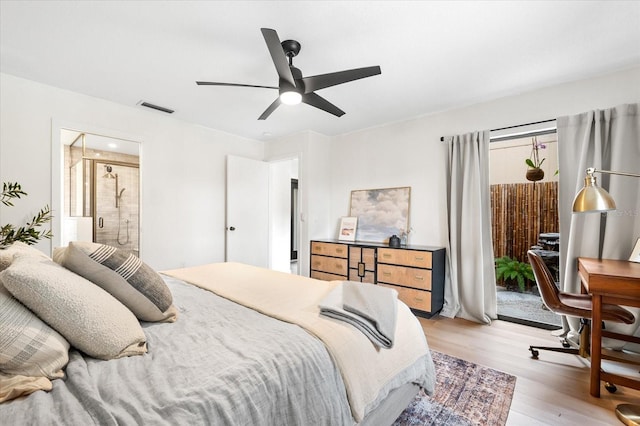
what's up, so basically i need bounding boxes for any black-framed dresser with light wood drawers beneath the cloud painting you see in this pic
[310,240,445,317]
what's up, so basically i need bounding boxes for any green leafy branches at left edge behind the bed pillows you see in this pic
[0,182,53,249]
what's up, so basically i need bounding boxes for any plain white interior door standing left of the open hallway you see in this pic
[225,155,269,268]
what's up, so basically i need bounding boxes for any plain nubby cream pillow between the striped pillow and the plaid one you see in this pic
[0,254,147,359]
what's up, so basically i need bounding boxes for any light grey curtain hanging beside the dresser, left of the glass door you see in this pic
[442,131,497,324]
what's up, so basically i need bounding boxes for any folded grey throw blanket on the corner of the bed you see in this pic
[319,281,398,348]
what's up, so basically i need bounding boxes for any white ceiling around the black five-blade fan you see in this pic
[0,0,640,140]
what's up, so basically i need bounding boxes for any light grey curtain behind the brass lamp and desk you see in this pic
[557,104,640,347]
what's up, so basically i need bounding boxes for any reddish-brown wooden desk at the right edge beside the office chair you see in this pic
[578,257,640,397]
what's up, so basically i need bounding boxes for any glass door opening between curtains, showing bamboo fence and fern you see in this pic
[489,129,561,329]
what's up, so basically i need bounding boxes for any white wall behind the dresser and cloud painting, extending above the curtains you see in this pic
[324,68,640,251]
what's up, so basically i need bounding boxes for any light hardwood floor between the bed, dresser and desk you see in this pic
[419,317,640,426]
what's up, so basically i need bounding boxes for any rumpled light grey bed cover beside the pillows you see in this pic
[0,277,354,426]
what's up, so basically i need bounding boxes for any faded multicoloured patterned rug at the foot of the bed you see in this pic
[393,351,516,426]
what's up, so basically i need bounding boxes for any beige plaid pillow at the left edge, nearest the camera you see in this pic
[0,284,69,379]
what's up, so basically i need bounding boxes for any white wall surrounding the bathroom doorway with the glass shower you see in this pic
[0,74,264,269]
